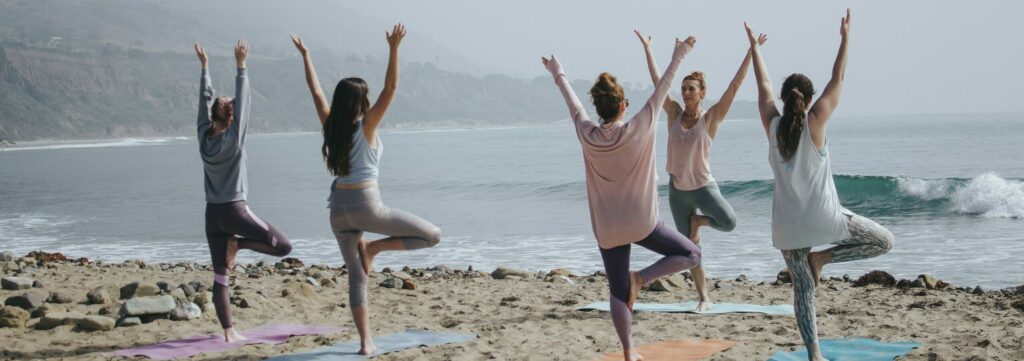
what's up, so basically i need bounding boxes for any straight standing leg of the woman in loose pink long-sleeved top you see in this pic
[600,241,640,361]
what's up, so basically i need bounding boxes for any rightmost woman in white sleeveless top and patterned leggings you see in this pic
[744,9,893,361]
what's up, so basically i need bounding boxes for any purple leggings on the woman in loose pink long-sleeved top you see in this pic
[600,222,700,348]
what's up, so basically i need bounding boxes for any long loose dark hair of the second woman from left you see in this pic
[321,78,370,177]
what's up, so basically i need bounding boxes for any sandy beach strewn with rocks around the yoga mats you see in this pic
[0,250,1024,360]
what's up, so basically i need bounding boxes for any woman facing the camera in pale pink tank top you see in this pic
[634,31,767,311]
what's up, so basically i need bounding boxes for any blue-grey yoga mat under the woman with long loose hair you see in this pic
[267,329,476,361]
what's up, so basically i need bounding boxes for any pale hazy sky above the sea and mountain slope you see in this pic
[339,0,1024,115]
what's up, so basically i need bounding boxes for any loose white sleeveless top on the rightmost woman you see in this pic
[768,117,850,247]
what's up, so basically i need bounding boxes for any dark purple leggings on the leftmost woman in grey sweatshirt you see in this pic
[206,200,292,328]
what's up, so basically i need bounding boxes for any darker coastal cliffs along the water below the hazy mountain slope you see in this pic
[0,46,577,141]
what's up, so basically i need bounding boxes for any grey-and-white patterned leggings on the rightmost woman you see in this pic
[782,211,893,356]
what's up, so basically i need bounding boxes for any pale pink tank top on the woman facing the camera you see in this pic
[665,111,715,190]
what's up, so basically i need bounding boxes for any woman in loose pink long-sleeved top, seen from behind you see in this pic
[542,37,700,361]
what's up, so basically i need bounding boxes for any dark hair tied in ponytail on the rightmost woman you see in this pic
[775,73,814,161]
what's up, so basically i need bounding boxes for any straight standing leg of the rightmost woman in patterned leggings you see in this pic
[782,247,824,361]
